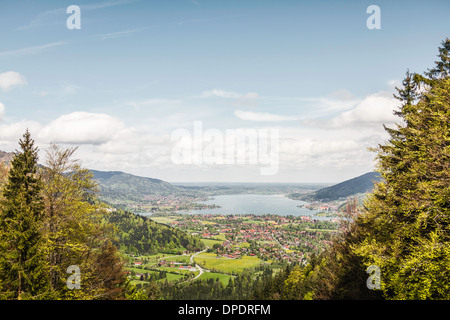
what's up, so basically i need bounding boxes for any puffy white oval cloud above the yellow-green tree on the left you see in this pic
[38,112,124,144]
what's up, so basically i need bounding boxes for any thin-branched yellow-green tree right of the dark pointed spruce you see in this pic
[41,144,125,299]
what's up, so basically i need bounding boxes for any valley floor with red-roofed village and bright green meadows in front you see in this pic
[123,213,340,282]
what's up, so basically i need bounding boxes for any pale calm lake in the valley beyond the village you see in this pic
[179,194,323,219]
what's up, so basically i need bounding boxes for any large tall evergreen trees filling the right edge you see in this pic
[354,45,450,299]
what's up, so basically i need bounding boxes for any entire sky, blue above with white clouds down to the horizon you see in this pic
[0,0,450,182]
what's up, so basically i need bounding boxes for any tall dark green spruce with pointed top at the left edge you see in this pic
[0,130,47,299]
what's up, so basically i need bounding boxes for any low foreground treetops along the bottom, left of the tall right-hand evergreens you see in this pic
[151,251,383,300]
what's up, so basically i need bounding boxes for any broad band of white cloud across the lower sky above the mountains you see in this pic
[0,86,396,182]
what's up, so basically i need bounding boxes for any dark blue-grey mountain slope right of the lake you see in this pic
[311,172,381,201]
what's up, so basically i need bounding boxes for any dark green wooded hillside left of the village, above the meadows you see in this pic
[107,209,204,255]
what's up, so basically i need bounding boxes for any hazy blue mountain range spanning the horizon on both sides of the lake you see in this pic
[0,151,381,201]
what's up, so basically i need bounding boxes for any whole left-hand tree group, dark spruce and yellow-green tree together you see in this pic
[0,138,126,300]
